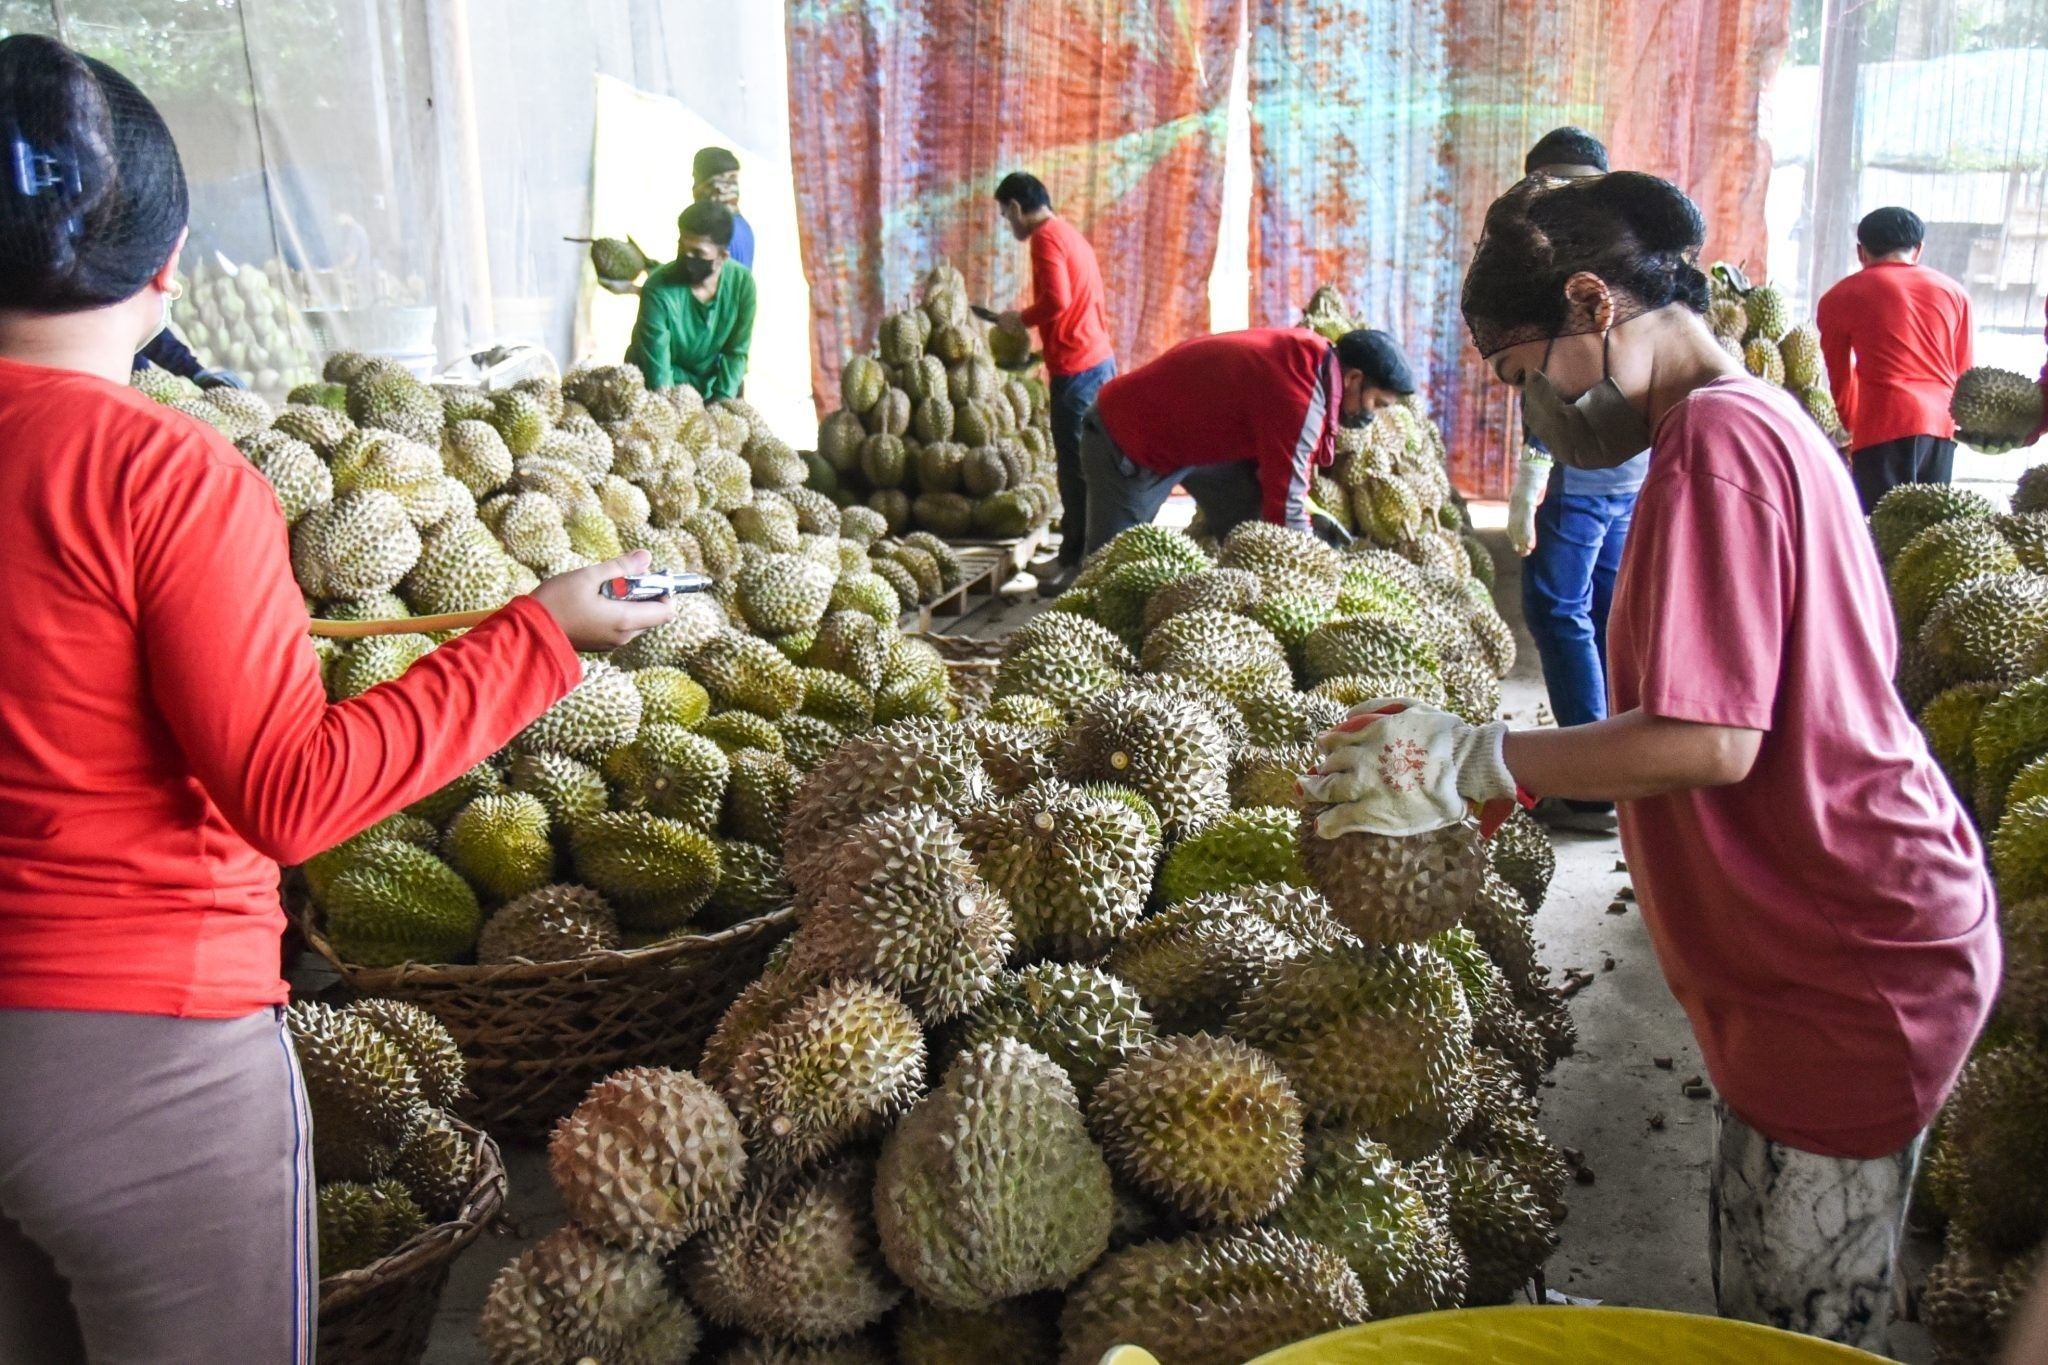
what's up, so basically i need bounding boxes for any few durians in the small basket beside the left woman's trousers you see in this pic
[285,1001,477,1277]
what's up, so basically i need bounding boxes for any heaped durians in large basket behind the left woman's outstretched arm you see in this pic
[134,356,958,966]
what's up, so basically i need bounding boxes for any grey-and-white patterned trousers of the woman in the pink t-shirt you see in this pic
[1708,1099,1923,1355]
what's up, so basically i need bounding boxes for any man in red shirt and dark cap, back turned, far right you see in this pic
[1817,209,1970,516]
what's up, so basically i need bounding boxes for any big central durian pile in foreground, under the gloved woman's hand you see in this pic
[479,509,1571,1365]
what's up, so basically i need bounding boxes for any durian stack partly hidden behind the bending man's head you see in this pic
[1302,284,1493,587]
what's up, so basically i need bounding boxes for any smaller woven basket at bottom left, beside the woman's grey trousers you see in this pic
[319,1124,506,1365]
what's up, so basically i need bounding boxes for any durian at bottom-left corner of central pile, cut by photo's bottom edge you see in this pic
[477,1224,702,1365]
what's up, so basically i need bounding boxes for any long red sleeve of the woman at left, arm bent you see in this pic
[133,458,582,864]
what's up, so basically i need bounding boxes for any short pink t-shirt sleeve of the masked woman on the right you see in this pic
[1628,471,1794,731]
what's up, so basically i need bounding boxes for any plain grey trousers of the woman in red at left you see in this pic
[0,1009,319,1365]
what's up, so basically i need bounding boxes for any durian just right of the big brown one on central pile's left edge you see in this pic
[961,782,1159,958]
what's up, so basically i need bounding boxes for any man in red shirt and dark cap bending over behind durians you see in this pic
[1081,327,1415,553]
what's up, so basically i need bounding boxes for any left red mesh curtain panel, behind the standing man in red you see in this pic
[788,0,1245,407]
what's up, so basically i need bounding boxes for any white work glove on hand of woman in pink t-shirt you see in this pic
[1300,698,1516,839]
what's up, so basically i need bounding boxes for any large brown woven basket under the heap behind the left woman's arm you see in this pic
[301,909,797,1142]
